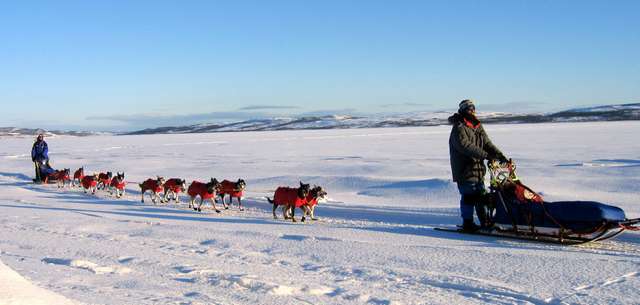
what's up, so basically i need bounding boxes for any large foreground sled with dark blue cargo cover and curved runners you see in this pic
[444,161,640,245]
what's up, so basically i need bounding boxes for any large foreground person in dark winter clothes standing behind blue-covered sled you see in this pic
[449,100,507,232]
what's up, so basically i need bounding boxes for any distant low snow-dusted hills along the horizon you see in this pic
[0,103,640,137]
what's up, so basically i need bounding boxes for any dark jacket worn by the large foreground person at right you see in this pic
[449,113,504,183]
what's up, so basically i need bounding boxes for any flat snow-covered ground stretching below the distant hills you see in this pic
[0,122,640,304]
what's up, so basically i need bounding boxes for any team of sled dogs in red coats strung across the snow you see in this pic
[58,167,327,222]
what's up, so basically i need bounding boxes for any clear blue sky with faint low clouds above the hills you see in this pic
[0,0,640,130]
